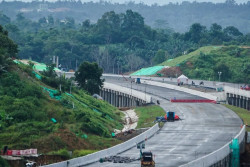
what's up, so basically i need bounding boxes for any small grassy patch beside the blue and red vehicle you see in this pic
[135,105,166,128]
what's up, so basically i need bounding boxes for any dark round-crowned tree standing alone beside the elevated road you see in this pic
[75,62,104,94]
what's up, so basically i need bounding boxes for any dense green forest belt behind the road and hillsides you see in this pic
[0,10,250,73]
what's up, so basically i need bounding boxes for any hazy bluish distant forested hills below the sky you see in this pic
[0,0,250,33]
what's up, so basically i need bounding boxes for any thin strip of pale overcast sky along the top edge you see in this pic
[0,0,250,5]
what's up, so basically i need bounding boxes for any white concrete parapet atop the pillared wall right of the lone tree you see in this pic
[103,82,152,103]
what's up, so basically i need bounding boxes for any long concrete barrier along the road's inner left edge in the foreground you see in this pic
[43,124,159,167]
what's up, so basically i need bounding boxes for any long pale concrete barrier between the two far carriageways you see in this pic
[141,80,217,101]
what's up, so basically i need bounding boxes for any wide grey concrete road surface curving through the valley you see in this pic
[84,78,242,167]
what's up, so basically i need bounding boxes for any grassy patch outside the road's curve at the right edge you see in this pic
[225,104,250,132]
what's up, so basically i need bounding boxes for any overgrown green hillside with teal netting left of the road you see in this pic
[0,64,122,153]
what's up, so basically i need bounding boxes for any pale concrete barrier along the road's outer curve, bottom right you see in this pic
[180,126,245,167]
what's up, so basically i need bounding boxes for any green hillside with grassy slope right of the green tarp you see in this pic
[160,46,250,83]
